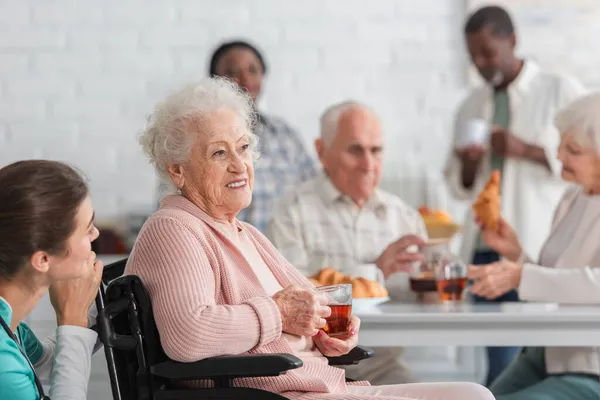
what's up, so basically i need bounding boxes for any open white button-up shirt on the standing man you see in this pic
[445,61,585,262]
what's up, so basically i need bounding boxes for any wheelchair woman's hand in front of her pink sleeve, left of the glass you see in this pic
[273,286,331,336]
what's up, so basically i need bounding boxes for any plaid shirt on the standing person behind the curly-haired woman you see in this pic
[237,114,316,232]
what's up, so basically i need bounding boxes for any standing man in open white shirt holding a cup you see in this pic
[445,6,584,384]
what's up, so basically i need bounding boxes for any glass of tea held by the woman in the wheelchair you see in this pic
[316,284,352,337]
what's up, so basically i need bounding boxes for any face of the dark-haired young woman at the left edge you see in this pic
[48,196,99,281]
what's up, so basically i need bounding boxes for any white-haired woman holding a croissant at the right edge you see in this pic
[469,93,600,400]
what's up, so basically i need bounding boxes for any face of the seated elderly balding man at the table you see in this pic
[317,107,383,207]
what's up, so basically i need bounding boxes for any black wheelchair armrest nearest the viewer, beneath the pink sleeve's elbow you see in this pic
[150,354,303,380]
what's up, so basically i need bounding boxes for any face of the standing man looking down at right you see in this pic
[466,26,515,87]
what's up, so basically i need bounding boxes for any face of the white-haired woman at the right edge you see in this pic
[558,133,600,189]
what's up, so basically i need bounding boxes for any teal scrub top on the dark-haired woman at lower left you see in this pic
[0,297,44,400]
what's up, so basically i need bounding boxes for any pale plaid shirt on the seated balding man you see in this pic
[267,174,427,276]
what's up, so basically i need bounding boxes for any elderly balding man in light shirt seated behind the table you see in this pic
[267,102,427,385]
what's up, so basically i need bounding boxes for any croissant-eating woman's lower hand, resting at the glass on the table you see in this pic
[467,261,523,299]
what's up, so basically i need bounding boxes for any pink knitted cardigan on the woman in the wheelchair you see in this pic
[126,196,365,399]
